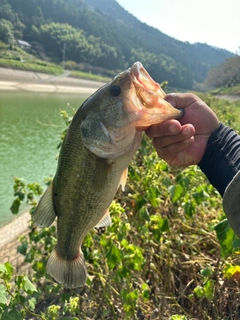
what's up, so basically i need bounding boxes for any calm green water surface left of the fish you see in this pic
[0,91,87,226]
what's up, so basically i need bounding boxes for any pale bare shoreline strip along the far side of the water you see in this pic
[0,67,105,94]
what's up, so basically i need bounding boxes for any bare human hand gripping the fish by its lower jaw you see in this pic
[146,93,219,167]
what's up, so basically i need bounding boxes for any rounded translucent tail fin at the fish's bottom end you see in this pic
[47,248,87,288]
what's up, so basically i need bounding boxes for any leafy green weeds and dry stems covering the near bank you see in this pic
[0,95,240,320]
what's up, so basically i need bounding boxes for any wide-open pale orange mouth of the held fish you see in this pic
[129,61,182,124]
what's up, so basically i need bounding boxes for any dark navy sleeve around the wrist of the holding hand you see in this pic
[198,123,240,196]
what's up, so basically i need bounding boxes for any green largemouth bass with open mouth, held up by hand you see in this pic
[32,61,181,288]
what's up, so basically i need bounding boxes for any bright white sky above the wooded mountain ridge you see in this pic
[116,0,240,53]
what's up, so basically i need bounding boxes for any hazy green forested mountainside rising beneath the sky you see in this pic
[0,0,236,89]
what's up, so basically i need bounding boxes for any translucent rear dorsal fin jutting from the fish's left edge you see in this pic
[32,182,56,228]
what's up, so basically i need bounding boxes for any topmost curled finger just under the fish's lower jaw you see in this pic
[146,120,181,138]
